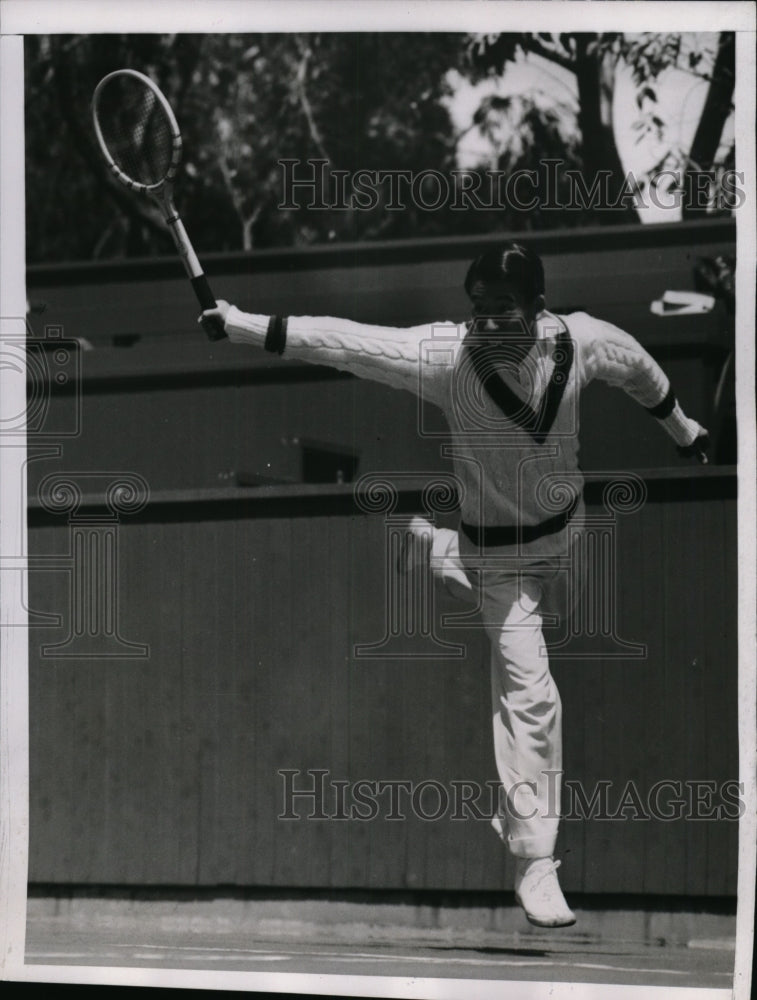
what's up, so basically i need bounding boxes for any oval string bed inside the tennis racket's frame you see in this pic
[96,76,179,187]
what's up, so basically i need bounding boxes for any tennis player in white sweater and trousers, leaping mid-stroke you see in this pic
[200,243,709,927]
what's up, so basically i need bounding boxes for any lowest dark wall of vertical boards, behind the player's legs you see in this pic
[30,480,738,896]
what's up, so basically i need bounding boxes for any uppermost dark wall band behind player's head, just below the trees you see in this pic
[27,222,735,352]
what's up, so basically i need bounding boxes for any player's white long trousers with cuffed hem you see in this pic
[428,525,575,858]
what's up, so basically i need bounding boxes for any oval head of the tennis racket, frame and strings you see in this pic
[92,69,181,193]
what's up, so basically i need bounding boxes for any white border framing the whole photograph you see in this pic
[0,0,757,1000]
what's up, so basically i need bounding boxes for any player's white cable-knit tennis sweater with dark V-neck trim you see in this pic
[225,306,702,528]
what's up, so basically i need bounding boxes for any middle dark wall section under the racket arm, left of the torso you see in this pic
[29,379,452,498]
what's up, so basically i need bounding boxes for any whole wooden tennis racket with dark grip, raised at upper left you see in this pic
[92,69,226,340]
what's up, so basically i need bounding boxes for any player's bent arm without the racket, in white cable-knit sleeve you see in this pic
[582,316,710,464]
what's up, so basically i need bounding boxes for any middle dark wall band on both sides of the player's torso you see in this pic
[28,360,728,516]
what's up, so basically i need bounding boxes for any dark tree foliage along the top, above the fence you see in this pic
[25,33,734,262]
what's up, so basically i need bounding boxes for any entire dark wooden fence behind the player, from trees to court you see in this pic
[29,224,738,896]
